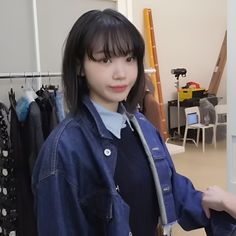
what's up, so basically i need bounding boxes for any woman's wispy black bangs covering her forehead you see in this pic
[85,15,144,60]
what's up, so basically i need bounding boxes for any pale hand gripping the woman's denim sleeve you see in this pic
[202,186,229,218]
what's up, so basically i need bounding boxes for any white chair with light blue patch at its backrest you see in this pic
[183,106,216,152]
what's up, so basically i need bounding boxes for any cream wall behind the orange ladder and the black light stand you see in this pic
[133,0,227,103]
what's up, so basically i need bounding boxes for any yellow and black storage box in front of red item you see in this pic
[179,88,206,102]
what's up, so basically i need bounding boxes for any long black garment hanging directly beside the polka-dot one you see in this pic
[9,93,37,236]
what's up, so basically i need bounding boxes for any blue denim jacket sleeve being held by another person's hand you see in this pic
[164,137,236,236]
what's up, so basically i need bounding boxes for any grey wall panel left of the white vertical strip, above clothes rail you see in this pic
[0,0,36,72]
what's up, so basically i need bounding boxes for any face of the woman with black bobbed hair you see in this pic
[83,50,138,111]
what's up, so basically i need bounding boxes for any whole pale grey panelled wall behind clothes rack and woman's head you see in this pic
[0,0,116,105]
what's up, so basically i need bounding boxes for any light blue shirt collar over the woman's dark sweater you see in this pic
[91,100,133,139]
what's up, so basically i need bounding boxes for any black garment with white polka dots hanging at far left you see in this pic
[0,103,17,235]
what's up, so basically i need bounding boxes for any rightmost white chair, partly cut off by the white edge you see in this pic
[214,104,227,140]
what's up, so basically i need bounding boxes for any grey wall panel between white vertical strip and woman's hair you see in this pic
[37,0,116,71]
